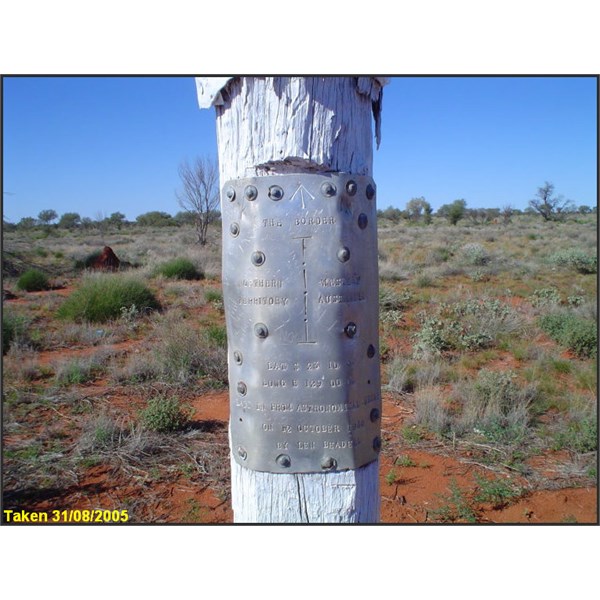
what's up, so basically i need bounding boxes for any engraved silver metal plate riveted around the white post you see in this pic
[221,173,381,473]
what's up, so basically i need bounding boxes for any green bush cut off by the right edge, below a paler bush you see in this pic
[538,312,598,358]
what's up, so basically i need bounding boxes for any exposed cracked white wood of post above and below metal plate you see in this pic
[196,77,386,523]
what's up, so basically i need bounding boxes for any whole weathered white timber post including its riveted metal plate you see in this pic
[196,77,385,523]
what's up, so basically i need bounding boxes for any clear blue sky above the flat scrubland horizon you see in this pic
[3,76,598,222]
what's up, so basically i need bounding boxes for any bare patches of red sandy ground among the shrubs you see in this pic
[3,290,597,523]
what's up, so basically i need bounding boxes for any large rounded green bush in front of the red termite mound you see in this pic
[58,274,160,323]
